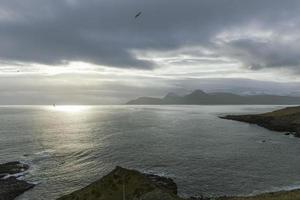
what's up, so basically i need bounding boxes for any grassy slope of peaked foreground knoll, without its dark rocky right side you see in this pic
[58,167,180,200]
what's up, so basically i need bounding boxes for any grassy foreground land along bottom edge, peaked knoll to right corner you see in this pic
[58,167,300,200]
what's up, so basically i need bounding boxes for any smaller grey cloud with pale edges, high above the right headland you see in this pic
[216,34,300,73]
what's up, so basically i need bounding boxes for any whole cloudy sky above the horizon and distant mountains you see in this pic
[0,0,300,104]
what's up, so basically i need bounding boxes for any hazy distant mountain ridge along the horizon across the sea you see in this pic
[126,90,300,105]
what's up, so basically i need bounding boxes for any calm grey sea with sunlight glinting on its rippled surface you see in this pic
[0,106,300,200]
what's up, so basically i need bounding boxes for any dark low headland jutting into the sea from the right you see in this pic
[220,106,300,137]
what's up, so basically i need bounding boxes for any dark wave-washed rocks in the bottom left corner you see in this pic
[0,162,34,200]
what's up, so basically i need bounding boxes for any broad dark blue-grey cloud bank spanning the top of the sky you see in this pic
[0,0,300,69]
